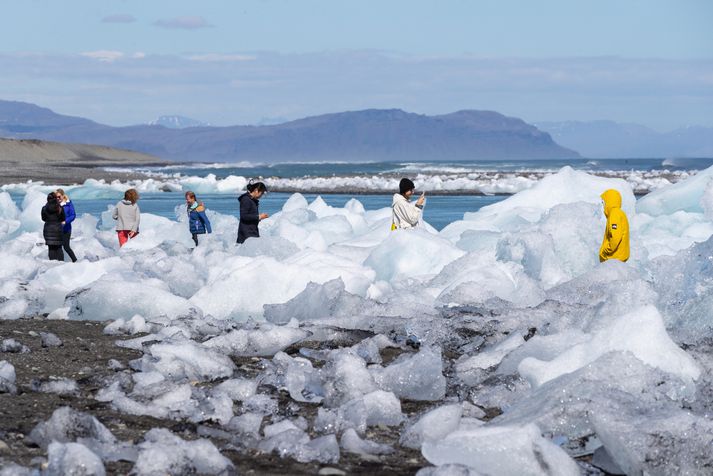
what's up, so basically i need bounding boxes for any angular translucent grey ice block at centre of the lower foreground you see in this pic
[369,347,446,401]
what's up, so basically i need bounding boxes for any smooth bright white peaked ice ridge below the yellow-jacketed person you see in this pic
[518,306,701,386]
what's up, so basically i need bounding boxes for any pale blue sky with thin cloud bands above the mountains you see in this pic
[0,0,713,130]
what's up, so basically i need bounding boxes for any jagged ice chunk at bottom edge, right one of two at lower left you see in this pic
[133,428,233,476]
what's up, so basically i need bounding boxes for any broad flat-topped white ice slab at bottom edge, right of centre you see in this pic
[421,425,580,476]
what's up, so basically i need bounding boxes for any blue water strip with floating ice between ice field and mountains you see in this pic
[4,159,713,230]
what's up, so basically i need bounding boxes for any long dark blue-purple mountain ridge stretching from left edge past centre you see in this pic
[0,101,579,162]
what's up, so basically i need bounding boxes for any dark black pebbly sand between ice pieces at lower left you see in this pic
[0,317,433,475]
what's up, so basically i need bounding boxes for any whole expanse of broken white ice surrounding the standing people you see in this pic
[0,167,713,476]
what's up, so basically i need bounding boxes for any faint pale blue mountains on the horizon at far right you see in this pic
[535,121,713,159]
